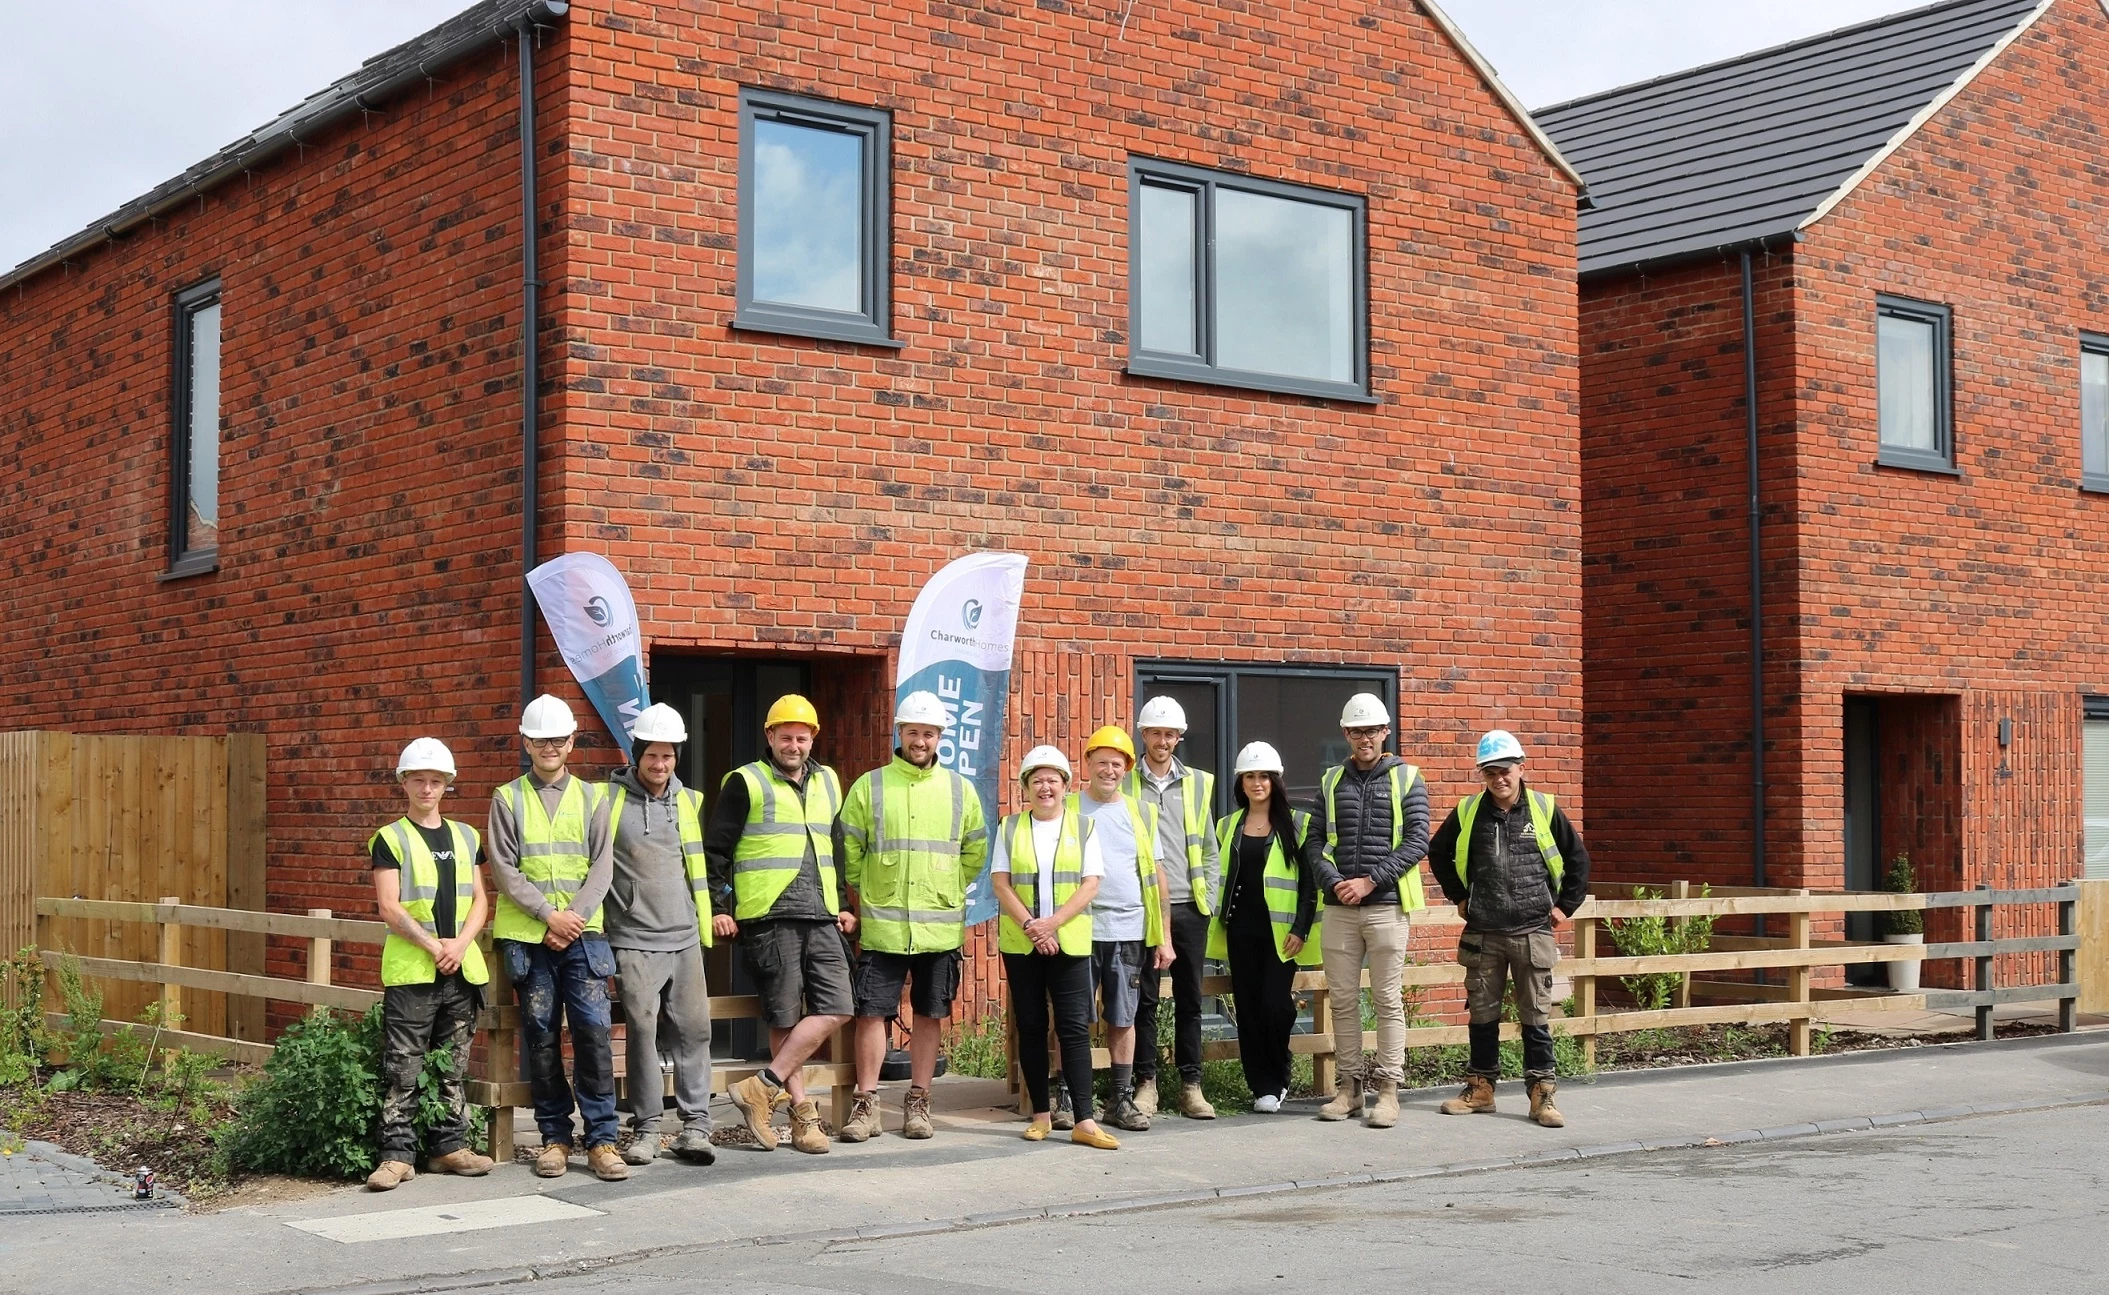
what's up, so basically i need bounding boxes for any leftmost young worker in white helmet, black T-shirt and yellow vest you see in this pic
[367,738,491,1192]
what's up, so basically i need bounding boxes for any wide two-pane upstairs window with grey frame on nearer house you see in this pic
[1128,158,1375,403]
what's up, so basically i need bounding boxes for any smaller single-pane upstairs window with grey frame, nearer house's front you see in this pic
[732,89,898,346]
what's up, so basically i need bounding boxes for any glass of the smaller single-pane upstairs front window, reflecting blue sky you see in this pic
[753,120,865,312]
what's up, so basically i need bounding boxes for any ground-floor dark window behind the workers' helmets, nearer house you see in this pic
[1135,660,1398,814]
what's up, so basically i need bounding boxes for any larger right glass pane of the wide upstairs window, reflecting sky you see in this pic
[1215,188,1354,382]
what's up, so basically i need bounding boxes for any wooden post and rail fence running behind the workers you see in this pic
[16,882,2109,1158]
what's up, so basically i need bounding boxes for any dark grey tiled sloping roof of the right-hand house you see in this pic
[1535,0,2052,274]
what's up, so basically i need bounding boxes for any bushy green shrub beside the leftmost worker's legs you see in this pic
[221,1004,483,1179]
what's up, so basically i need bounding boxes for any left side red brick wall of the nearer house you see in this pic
[0,49,563,995]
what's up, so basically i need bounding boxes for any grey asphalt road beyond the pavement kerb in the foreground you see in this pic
[538,1107,2109,1295]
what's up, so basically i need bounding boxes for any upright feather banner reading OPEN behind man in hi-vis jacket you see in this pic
[894,553,1025,926]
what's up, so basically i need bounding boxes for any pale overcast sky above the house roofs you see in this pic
[0,0,1917,266]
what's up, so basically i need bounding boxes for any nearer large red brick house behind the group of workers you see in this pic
[0,0,1582,1025]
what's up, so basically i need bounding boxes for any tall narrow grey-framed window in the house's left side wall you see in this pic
[167,278,219,578]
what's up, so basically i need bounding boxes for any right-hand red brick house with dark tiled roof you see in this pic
[1537,0,2109,978]
